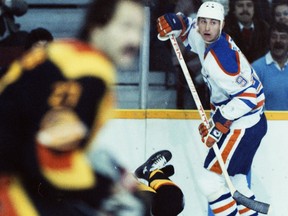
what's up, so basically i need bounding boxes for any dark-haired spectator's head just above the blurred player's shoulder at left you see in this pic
[24,27,54,50]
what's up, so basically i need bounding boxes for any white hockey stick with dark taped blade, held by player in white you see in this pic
[169,35,270,214]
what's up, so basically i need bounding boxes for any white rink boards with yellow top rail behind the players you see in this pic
[94,110,288,216]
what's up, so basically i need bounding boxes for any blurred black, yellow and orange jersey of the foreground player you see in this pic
[0,40,115,215]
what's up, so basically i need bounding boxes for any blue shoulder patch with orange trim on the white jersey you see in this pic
[206,34,240,76]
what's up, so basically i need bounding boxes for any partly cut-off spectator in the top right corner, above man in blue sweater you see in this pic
[272,0,288,25]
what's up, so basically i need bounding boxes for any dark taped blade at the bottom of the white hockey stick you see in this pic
[233,191,270,214]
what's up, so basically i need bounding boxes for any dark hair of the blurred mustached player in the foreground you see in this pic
[78,0,143,41]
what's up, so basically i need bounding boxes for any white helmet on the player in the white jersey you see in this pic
[196,1,224,27]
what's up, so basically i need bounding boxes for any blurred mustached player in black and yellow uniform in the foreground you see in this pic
[0,0,144,216]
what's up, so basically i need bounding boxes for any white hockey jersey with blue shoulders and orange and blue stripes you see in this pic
[183,21,265,129]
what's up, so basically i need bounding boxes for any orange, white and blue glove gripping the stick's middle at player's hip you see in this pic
[198,109,233,148]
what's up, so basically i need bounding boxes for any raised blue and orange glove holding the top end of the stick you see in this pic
[157,13,189,41]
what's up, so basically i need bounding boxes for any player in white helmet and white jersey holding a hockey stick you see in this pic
[157,1,267,216]
